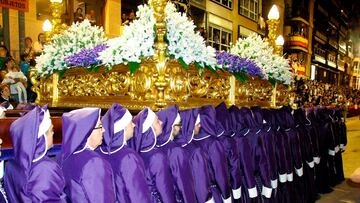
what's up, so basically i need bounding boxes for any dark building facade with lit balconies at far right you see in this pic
[311,0,353,86]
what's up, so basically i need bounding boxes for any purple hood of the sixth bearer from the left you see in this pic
[174,109,200,147]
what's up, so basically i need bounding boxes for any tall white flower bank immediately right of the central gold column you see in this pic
[165,2,216,70]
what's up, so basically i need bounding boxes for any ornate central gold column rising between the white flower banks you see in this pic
[151,0,169,108]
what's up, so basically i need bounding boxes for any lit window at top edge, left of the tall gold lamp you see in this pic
[239,0,261,21]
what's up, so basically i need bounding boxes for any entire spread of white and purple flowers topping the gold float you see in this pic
[36,2,292,84]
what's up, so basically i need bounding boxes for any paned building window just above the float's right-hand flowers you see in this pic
[208,25,232,51]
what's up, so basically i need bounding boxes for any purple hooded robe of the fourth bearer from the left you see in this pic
[131,108,176,203]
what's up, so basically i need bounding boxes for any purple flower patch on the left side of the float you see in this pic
[65,44,108,67]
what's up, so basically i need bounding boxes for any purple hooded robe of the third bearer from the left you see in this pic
[99,103,151,203]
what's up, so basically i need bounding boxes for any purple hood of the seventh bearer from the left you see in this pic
[194,105,224,140]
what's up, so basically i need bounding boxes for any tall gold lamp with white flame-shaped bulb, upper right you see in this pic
[266,4,280,49]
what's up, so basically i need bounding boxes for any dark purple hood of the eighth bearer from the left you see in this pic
[215,102,234,136]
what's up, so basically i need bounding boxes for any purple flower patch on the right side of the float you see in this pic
[216,51,263,77]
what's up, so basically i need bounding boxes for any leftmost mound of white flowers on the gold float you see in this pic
[36,20,106,76]
